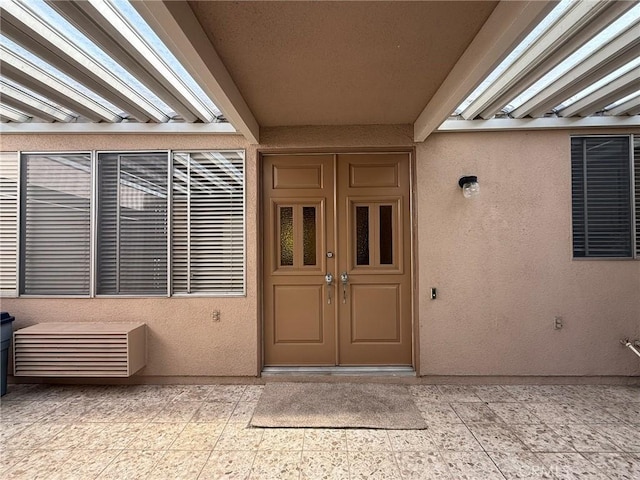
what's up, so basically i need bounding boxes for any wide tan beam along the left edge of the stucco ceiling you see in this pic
[132,0,260,143]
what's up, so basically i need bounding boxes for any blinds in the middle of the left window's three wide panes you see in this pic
[97,152,168,295]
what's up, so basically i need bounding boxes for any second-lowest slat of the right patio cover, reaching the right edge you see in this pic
[558,67,640,117]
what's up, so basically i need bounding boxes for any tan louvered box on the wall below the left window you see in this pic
[13,323,146,377]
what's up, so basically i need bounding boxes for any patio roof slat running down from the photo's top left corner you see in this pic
[2,1,169,122]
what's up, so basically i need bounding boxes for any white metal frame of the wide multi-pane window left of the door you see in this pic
[15,148,247,298]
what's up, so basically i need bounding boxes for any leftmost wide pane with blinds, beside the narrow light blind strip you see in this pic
[20,153,91,295]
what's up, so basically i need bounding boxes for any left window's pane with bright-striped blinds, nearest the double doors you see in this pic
[172,151,245,295]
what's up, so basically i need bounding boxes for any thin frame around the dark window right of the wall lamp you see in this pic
[569,133,640,261]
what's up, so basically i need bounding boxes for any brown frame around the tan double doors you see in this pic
[256,147,420,377]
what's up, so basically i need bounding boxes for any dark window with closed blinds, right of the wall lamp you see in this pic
[571,135,640,258]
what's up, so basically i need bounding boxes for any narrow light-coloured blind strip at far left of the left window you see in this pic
[0,152,19,296]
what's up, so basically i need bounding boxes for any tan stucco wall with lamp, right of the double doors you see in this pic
[417,131,640,375]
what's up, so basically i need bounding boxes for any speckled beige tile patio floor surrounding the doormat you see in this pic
[0,385,640,480]
